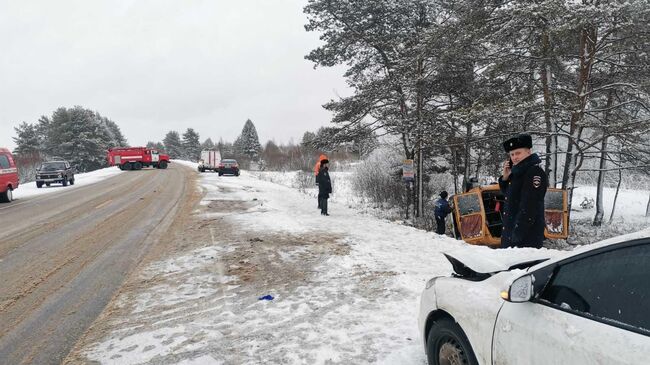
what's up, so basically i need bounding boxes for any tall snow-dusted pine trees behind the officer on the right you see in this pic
[304,0,650,225]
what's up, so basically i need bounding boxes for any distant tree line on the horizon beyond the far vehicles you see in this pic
[13,106,366,181]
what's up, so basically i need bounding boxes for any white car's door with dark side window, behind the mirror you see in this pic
[492,244,650,365]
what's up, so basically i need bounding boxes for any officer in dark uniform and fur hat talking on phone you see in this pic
[499,134,548,248]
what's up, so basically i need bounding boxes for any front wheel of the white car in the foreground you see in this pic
[427,318,478,365]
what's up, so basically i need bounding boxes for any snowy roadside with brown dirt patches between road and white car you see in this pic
[71,164,648,364]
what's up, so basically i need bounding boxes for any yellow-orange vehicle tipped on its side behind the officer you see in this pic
[451,184,569,247]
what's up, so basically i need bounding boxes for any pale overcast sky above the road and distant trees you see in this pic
[0,0,350,149]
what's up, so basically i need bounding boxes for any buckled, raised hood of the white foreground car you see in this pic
[443,247,560,280]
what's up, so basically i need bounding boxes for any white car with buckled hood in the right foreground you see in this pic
[418,234,650,365]
